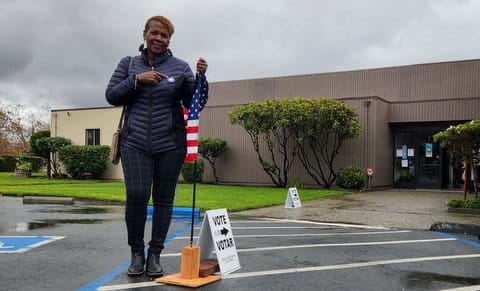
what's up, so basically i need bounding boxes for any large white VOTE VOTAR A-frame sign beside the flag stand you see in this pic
[198,209,241,275]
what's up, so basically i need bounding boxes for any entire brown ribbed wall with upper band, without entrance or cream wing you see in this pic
[202,60,480,186]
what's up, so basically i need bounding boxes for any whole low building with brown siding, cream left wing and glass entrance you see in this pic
[51,59,480,189]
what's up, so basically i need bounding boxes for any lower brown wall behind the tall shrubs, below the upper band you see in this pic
[200,97,382,186]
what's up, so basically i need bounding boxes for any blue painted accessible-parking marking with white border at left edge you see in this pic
[0,236,64,254]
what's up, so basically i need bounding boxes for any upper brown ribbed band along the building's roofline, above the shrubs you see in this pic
[209,59,480,106]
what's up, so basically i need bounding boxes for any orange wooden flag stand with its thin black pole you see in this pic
[155,160,222,288]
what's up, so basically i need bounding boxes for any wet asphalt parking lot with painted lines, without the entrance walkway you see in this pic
[0,196,480,290]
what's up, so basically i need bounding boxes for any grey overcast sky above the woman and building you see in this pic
[0,0,480,113]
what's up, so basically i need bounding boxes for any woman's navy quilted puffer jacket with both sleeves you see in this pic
[105,51,208,154]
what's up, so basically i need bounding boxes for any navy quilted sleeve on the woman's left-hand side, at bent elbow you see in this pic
[105,57,135,106]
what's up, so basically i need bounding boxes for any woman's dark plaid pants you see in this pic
[121,147,186,252]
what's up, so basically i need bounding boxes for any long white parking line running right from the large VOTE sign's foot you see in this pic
[222,254,480,279]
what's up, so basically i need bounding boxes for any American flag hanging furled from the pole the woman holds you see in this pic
[183,75,208,163]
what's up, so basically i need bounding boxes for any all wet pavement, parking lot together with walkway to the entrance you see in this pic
[0,190,480,291]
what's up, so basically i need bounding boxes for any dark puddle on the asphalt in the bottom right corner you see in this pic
[406,272,480,288]
